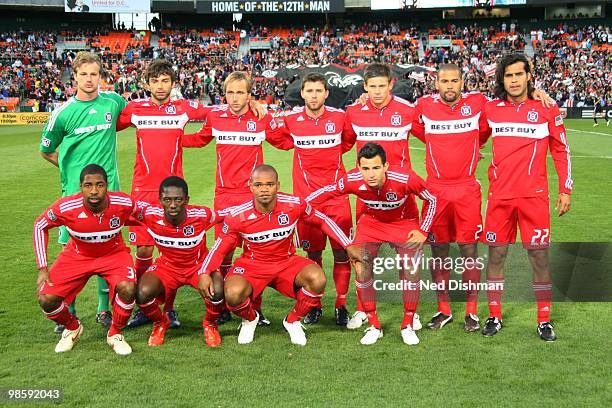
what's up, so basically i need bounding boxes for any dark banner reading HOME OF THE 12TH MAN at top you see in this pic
[196,0,345,14]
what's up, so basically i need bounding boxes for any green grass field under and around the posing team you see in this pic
[0,120,612,407]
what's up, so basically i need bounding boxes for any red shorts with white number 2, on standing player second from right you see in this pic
[422,181,482,244]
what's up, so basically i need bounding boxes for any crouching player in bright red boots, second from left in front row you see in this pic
[136,176,223,347]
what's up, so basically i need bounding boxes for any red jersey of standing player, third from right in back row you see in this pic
[344,96,416,168]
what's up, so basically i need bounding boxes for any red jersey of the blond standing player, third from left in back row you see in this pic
[198,105,286,194]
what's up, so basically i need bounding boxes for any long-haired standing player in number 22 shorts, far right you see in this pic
[482,54,573,341]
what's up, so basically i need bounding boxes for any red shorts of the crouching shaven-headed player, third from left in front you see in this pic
[225,255,318,299]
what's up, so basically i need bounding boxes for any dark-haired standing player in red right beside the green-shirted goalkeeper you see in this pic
[117,59,265,328]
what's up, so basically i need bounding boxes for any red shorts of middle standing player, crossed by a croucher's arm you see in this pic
[297,197,353,252]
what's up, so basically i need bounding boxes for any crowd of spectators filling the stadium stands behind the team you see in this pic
[0,22,612,110]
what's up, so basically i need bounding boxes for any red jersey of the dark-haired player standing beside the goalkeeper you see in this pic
[117,99,212,193]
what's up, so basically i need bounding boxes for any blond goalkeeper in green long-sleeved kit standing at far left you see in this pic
[40,52,126,331]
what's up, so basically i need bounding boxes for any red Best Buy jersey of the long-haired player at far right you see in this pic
[484,99,574,198]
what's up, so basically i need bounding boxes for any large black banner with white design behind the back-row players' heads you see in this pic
[262,64,435,108]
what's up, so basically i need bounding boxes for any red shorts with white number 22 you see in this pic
[482,195,550,249]
